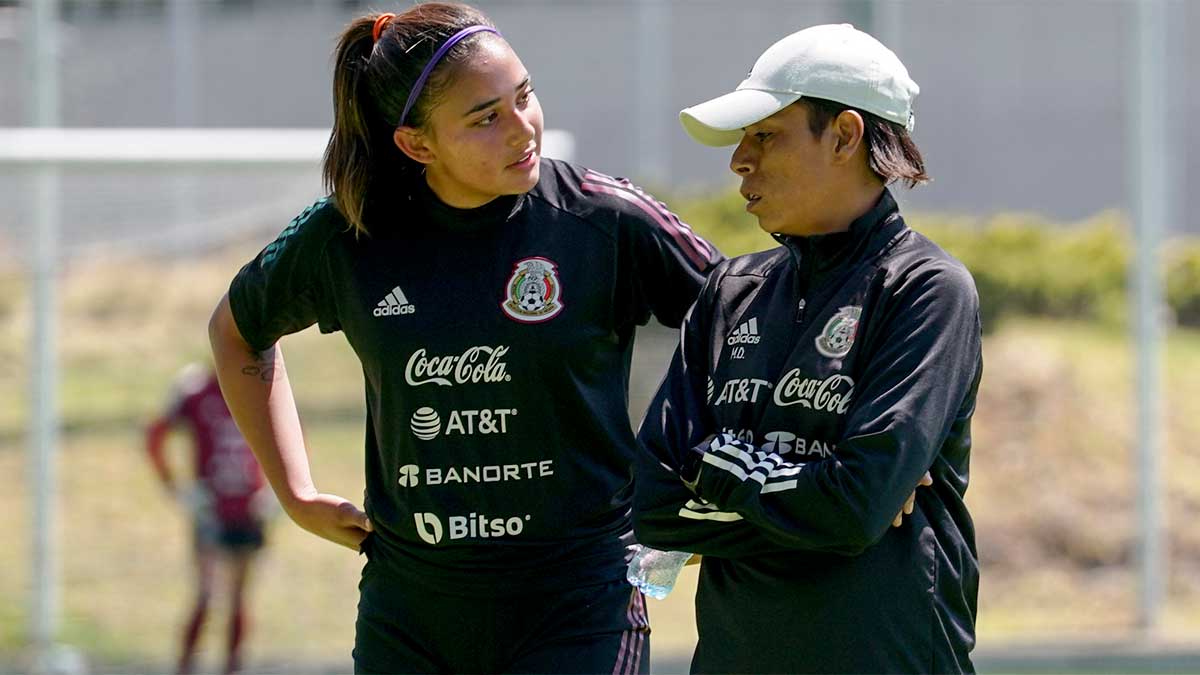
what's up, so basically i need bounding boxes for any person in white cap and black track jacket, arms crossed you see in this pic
[634,24,983,673]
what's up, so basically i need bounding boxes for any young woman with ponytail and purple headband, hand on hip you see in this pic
[210,2,720,673]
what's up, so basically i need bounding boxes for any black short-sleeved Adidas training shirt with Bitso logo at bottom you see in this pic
[229,160,720,592]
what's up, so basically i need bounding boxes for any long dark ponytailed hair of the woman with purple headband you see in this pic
[322,2,496,233]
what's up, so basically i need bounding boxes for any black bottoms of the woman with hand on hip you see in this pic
[354,554,650,675]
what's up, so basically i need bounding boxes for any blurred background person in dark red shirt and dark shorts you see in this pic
[146,364,275,673]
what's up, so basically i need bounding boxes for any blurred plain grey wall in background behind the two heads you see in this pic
[0,0,1200,243]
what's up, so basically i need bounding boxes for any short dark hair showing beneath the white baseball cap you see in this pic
[797,98,930,187]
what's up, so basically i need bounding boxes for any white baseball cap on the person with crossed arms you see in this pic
[679,24,920,145]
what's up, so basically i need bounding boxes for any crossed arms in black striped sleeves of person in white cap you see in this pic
[634,263,980,557]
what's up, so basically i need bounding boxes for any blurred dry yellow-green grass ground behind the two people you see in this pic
[0,245,1200,670]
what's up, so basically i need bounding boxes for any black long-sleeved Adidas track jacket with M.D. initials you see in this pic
[634,192,982,673]
